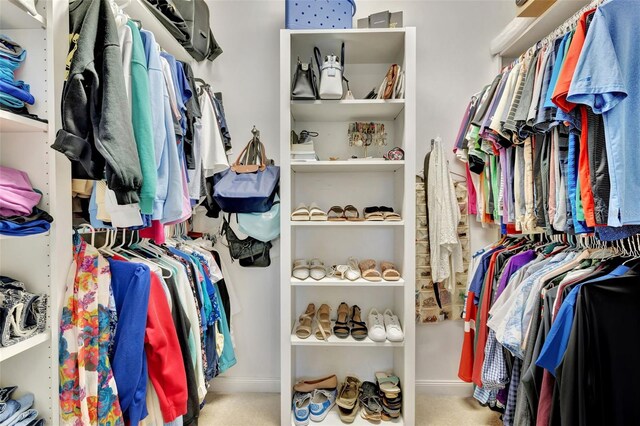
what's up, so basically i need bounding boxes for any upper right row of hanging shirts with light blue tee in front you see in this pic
[455,0,640,239]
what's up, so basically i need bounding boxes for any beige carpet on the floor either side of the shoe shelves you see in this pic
[198,393,502,426]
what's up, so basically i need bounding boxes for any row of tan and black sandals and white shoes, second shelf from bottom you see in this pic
[295,302,404,342]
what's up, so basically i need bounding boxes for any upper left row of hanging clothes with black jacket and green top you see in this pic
[53,0,231,242]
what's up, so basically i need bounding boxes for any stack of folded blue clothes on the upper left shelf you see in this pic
[0,34,35,110]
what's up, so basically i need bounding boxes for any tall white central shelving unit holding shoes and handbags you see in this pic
[280,28,416,426]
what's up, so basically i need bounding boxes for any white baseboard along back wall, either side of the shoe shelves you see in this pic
[209,376,473,396]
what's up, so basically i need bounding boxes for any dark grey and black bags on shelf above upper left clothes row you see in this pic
[145,0,222,61]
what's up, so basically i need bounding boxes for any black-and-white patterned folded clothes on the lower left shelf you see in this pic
[0,276,47,350]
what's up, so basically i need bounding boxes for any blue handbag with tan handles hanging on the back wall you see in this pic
[213,135,280,213]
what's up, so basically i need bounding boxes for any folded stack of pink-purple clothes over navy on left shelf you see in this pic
[0,166,53,236]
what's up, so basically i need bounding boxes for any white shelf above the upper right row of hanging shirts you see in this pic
[500,0,591,58]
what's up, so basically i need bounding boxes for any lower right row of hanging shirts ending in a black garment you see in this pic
[458,237,640,426]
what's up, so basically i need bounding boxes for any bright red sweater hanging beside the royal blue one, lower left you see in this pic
[144,272,187,423]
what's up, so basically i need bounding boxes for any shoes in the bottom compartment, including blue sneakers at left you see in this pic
[292,372,402,426]
